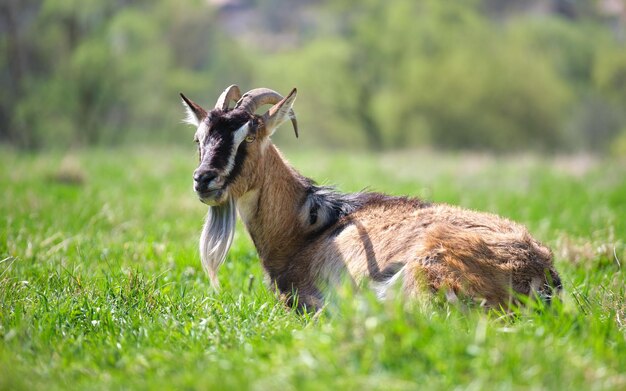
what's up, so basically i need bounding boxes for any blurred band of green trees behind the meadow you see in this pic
[0,0,626,154]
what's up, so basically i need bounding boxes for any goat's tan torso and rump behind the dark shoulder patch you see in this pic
[303,197,560,305]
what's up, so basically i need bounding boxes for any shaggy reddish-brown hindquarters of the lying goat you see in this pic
[404,224,561,308]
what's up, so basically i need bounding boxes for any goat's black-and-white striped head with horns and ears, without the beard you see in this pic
[181,85,298,205]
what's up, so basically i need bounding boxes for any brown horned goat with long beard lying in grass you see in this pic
[180,85,561,310]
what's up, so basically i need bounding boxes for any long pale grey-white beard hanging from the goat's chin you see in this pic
[200,196,237,289]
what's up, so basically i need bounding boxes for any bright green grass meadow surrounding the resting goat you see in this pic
[0,145,626,390]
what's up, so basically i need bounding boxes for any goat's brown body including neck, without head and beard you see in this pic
[237,145,560,307]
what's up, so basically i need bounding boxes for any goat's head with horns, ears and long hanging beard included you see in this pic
[181,85,298,287]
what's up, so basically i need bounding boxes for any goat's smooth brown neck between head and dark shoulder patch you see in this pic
[237,144,307,275]
